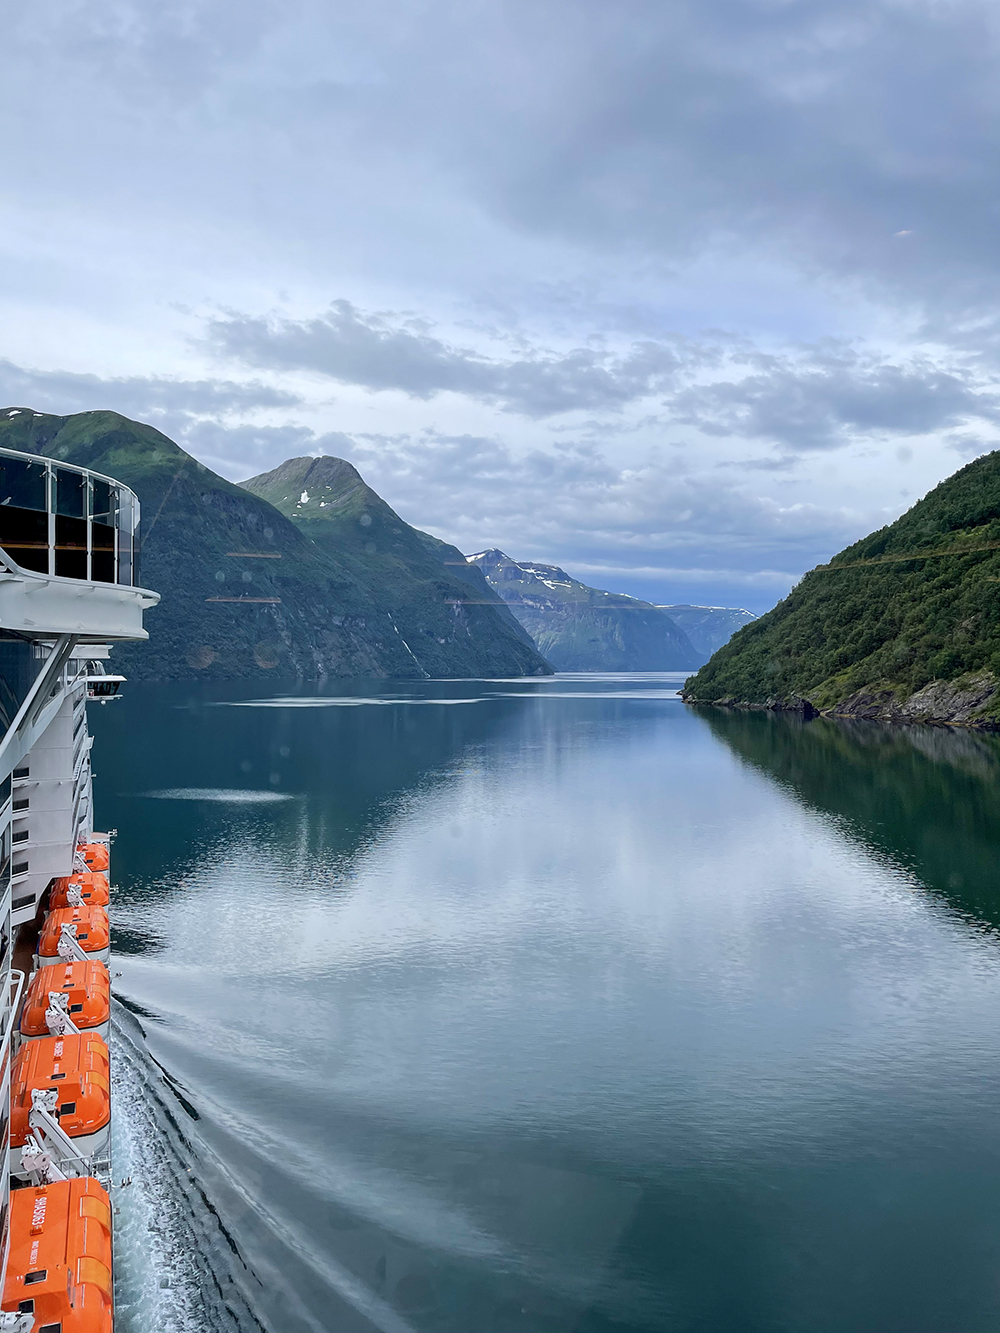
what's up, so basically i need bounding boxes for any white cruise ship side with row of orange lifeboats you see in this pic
[0,449,159,1333]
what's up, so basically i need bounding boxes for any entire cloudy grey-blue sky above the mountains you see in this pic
[0,0,1000,611]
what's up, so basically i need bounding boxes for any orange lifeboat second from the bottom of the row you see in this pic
[11,1032,111,1174]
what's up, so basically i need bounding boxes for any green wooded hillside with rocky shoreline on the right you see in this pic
[685,452,1000,725]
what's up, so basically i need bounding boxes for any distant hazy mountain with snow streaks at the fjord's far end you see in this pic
[468,549,704,670]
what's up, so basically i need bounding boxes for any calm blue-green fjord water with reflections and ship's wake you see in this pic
[93,676,1000,1333]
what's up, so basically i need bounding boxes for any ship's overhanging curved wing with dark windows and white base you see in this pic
[0,449,159,643]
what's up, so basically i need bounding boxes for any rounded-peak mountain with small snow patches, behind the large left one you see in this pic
[243,457,551,676]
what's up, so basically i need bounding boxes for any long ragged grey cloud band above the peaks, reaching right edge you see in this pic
[208,300,1000,452]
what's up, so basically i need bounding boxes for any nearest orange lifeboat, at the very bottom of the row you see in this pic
[3,1177,113,1333]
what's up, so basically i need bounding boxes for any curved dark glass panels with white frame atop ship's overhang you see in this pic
[0,449,139,588]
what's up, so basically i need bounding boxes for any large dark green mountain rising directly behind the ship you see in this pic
[0,408,548,680]
